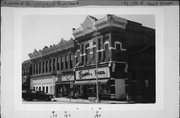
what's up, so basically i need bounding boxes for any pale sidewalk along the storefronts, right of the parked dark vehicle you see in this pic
[53,97,128,104]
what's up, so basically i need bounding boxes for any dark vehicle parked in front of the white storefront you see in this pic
[22,90,53,101]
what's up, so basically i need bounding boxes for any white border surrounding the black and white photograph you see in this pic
[13,7,164,111]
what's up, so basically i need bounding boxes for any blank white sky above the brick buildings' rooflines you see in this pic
[22,14,155,61]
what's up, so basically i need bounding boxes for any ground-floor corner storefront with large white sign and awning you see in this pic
[74,67,125,99]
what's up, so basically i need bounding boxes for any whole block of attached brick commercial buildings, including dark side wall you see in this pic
[22,15,155,103]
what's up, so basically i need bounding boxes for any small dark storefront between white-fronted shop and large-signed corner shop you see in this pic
[56,73,74,97]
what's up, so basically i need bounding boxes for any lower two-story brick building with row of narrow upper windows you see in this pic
[29,39,75,96]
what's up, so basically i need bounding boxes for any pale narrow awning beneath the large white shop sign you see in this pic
[74,79,109,85]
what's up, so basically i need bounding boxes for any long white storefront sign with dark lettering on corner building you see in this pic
[76,67,110,80]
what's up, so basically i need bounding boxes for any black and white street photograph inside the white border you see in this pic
[22,14,156,104]
